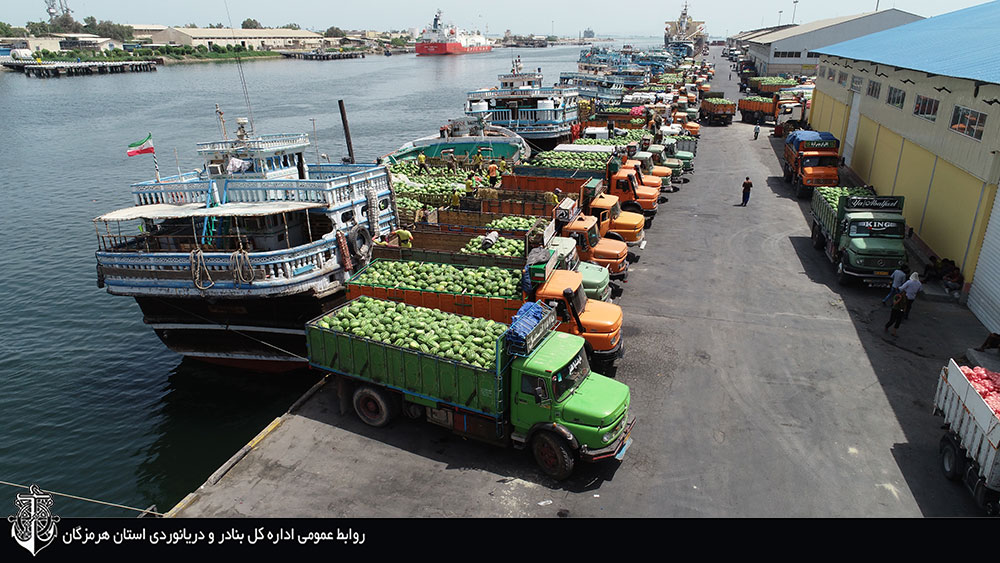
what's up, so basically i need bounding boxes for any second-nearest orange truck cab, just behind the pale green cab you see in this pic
[553,198,628,279]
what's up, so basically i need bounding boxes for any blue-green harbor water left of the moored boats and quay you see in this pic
[0,44,640,516]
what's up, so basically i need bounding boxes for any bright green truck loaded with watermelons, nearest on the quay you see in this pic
[306,297,635,479]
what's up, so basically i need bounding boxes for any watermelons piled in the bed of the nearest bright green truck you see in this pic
[316,296,507,369]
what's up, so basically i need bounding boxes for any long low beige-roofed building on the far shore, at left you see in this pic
[151,27,331,51]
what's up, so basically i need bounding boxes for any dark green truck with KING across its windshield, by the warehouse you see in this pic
[811,187,907,287]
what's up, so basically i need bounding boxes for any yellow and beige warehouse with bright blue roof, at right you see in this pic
[809,2,1000,332]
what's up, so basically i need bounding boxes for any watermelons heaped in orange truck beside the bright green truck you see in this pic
[351,260,521,297]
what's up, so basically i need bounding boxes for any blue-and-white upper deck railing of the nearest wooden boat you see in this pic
[126,164,389,207]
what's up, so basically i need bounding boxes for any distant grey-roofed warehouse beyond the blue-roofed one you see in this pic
[742,8,923,76]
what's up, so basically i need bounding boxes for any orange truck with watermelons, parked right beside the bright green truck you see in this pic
[347,259,625,364]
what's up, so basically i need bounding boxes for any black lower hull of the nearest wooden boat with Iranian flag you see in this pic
[136,290,347,373]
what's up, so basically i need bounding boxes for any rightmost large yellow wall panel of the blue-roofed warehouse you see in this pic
[920,158,983,277]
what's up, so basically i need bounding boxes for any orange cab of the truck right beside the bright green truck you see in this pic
[533,270,625,363]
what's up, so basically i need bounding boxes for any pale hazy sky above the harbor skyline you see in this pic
[0,0,984,37]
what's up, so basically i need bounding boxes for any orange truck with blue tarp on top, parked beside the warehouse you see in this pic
[782,131,840,198]
